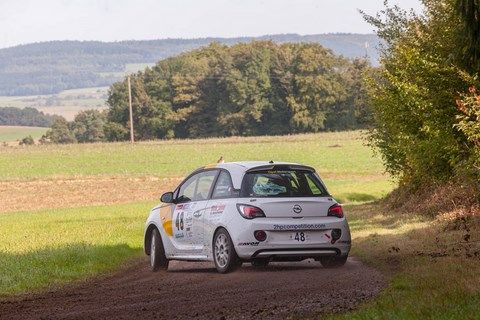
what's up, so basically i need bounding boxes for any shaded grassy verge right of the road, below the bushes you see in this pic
[322,203,480,319]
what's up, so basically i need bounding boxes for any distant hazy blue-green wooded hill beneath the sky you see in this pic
[0,34,379,96]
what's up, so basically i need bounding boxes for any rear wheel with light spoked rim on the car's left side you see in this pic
[213,228,242,273]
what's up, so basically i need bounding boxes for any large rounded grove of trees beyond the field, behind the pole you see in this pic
[105,41,369,140]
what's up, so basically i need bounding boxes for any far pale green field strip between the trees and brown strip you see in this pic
[0,131,392,201]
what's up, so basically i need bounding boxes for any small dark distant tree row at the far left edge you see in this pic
[0,107,57,127]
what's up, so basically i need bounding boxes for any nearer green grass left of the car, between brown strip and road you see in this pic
[0,202,150,296]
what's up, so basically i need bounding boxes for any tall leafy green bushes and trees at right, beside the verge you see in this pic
[365,0,480,192]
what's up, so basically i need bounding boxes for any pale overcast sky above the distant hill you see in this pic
[0,0,421,48]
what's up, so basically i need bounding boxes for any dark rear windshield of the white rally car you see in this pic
[240,170,328,197]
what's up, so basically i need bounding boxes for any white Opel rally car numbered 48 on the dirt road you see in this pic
[144,161,351,273]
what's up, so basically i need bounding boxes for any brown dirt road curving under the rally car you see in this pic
[0,258,384,320]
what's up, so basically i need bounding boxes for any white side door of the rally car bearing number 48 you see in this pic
[172,171,217,256]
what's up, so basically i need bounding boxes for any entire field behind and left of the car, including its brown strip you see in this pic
[0,132,393,294]
